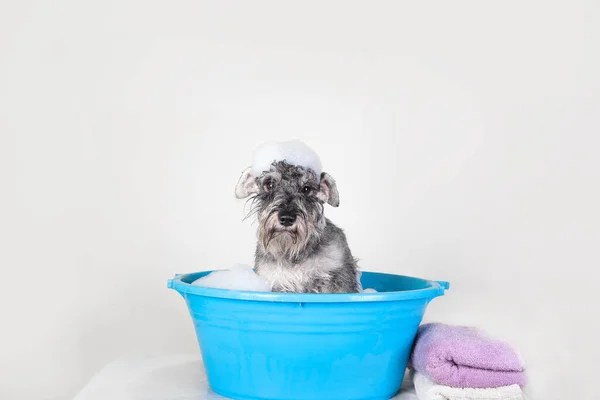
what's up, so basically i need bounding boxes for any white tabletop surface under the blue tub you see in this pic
[73,354,417,400]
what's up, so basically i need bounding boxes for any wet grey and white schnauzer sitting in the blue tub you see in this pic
[235,161,361,293]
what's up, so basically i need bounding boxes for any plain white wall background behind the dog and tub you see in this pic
[0,0,600,400]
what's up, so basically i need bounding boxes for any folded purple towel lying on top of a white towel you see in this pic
[410,323,526,388]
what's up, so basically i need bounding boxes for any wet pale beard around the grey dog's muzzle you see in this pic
[258,211,316,259]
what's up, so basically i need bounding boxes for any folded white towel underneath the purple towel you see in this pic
[413,372,525,400]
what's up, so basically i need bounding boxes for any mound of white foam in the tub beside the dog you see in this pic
[192,264,271,292]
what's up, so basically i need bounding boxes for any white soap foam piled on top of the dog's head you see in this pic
[252,140,323,176]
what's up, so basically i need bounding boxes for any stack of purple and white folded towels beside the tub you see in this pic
[410,323,526,400]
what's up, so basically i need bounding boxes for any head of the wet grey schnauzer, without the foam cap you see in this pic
[235,161,340,258]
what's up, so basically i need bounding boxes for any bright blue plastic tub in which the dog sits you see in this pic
[168,271,449,400]
